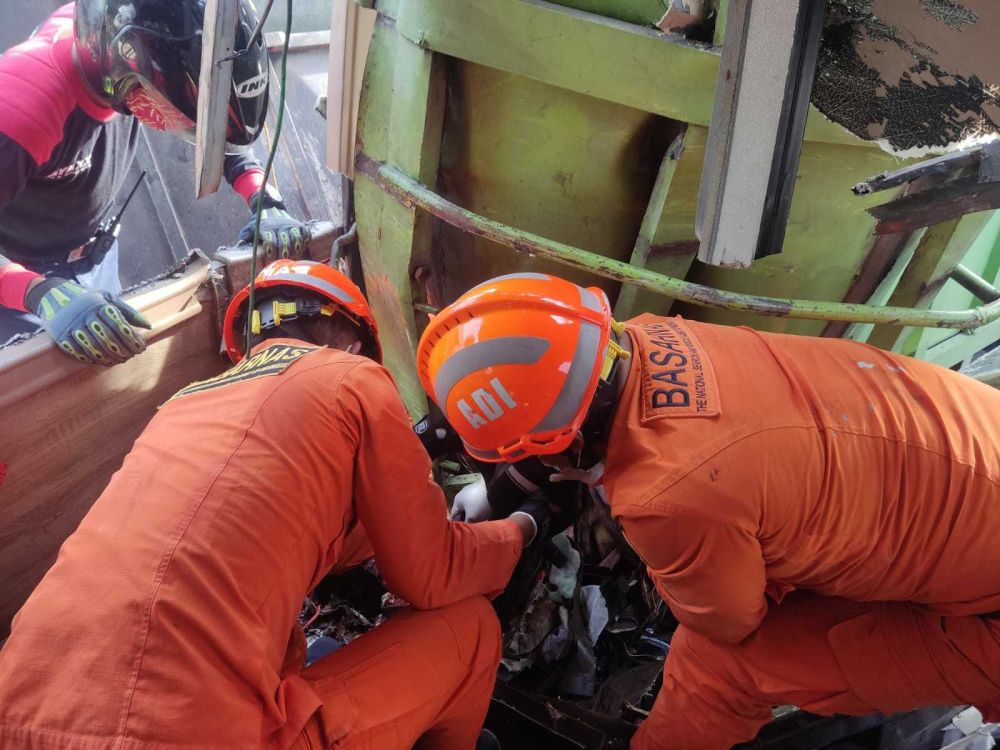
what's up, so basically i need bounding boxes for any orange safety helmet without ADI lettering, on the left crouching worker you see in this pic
[222,258,382,363]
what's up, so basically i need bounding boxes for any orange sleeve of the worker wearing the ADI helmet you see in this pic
[615,505,767,643]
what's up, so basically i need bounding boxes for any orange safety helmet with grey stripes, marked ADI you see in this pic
[417,273,622,462]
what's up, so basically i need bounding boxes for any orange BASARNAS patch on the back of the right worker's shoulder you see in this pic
[629,318,722,422]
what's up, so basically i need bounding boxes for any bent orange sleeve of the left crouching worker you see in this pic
[335,362,522,609]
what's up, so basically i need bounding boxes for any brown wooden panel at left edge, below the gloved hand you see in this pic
[0,262,225,638]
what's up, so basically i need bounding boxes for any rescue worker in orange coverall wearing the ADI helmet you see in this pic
[418,274,1000,750]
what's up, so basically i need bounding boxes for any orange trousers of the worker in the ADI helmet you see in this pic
[632,593,1000,750]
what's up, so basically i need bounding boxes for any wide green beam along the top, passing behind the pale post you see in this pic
[396,0,864,150]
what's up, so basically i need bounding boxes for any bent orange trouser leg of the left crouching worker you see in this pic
[292,596,500,750]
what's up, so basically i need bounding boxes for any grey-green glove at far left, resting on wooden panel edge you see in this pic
[24,278,152,367]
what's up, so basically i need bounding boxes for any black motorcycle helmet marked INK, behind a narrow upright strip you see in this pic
[73,0,268,151]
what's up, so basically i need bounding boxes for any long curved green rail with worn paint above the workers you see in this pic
[357,153,1000,330]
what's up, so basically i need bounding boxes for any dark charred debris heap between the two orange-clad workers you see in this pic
[494,485,677,748]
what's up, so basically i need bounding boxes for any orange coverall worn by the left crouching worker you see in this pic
[0,339,521,750]
